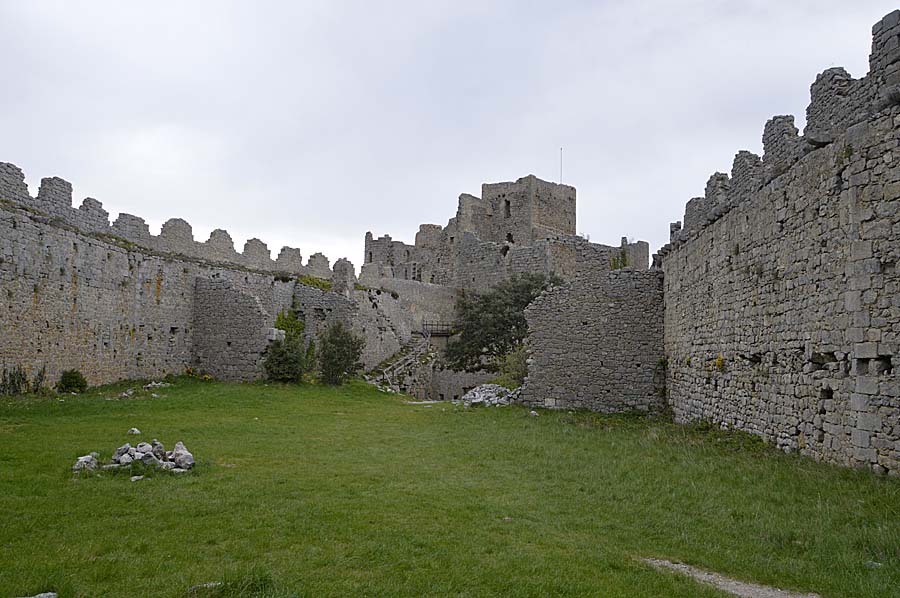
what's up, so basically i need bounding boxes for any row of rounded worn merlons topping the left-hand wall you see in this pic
[0,162,332,279]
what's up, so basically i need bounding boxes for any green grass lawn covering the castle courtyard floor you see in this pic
[0,379,900,597]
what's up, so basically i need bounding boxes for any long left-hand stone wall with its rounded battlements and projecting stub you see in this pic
[0,164,464,384]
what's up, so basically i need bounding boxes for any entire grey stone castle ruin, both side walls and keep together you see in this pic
[0,11,900,475]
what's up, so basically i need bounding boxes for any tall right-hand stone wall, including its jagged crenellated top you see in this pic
[654,12,900,473]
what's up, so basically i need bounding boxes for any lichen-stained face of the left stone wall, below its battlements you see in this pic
[0,199,292,384]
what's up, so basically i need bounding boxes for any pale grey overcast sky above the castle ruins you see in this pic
[0,0,897,267]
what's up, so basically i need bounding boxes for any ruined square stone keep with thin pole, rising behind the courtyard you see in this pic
[360,175,650,290]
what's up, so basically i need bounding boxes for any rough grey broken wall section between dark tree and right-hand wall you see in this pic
[521,269,665,413]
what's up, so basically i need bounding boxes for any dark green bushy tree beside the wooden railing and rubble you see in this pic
[447,274,561,372]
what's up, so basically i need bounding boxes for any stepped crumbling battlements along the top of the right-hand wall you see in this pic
[654,10,900,262]
